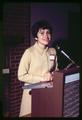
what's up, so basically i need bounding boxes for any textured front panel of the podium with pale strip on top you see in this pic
[63,73,80,117]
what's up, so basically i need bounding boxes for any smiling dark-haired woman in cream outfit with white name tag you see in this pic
[18,20,58,117]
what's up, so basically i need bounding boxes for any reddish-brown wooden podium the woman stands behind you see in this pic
[31,67,80,117]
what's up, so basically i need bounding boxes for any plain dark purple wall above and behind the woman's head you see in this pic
[31,2,80,39]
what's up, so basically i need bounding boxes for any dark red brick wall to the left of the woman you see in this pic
[0,2,30,117]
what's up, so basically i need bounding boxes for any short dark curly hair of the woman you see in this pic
[31,20,52,38]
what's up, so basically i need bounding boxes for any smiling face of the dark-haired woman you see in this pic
[37,28,51,45]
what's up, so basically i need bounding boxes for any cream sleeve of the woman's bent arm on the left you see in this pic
[18,49,43,84]
